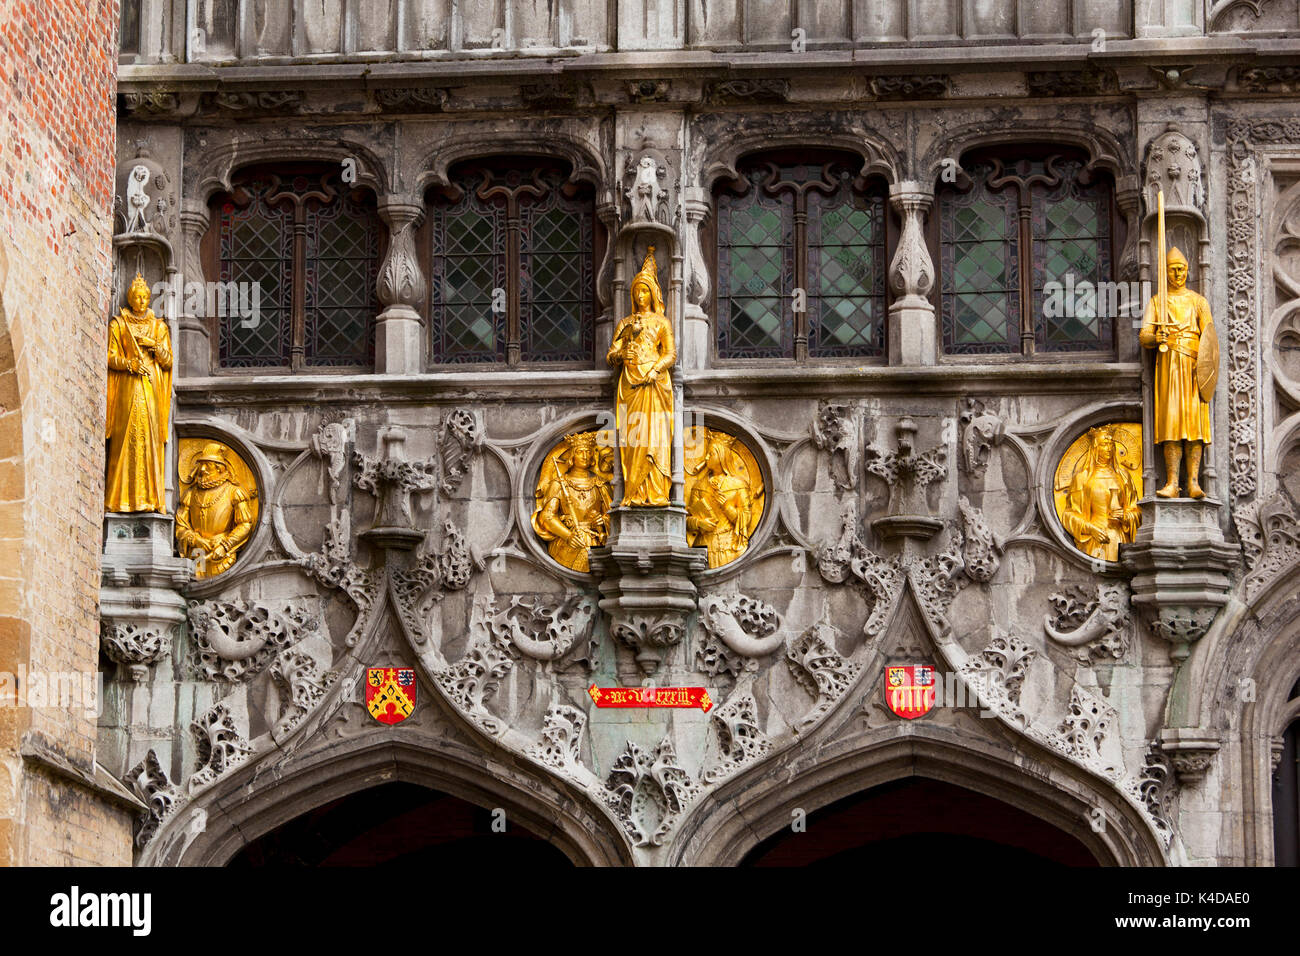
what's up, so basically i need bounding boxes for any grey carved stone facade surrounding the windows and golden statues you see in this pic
[87,0,1300,865]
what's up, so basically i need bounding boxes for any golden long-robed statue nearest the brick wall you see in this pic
[104,273,172,514]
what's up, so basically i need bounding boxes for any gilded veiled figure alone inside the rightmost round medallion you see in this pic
[1057,425,1141,561]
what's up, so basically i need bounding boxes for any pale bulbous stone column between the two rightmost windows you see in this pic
[885,179,939,365]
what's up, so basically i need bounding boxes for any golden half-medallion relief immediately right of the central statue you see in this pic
[686,427,763,567]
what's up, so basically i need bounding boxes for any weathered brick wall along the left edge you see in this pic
[0,0,130,864]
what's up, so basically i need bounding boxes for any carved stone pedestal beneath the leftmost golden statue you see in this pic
[99,514,194,682]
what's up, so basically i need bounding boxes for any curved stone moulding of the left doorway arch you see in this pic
[148,727,632,866]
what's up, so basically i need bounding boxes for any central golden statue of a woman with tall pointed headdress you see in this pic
[605,246,677,505]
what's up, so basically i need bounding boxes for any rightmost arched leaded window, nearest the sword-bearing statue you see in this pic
[939,148,1131,355]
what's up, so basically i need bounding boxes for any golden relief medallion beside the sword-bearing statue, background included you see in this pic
[1056,424,1141,561]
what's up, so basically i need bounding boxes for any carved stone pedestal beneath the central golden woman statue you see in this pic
[589,505,709,675]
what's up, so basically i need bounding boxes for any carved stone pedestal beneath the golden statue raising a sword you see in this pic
[1121,497,1238,662]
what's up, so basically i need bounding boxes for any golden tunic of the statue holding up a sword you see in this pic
[1138,289,1214,445]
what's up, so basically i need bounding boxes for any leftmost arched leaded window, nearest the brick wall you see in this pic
[204,166,384,369]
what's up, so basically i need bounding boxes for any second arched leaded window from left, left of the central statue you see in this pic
[426,160,598,365]
